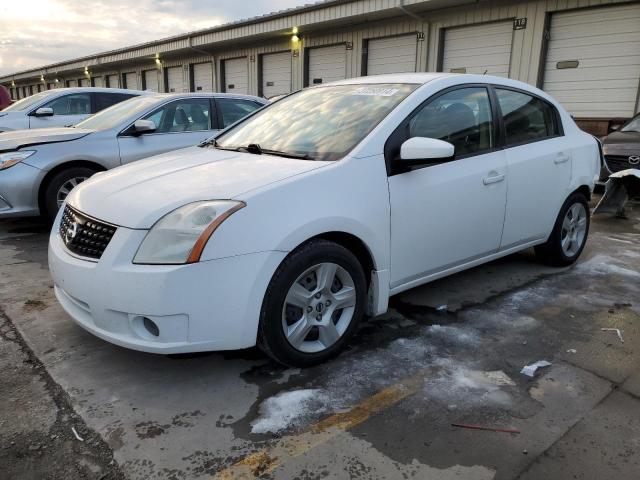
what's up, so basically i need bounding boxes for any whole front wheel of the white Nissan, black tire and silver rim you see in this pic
[258,239,367,367]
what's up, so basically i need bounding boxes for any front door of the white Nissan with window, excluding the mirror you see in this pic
[389,86,507,293]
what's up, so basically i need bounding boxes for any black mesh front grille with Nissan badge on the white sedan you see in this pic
[60,205,117,260]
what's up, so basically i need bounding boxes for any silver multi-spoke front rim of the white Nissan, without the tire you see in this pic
[282,263,356,353]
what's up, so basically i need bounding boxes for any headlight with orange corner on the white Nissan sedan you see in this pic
[133,200,246,265]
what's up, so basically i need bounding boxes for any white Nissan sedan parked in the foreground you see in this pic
[49,74,600,366]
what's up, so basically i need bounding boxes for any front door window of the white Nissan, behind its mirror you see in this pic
[409,87,495,157]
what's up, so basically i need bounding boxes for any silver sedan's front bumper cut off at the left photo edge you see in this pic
[0,162,46,218]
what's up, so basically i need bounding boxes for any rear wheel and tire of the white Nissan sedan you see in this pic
[535,192,591,267]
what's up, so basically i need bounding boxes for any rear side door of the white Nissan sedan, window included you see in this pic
[495,87,572,250]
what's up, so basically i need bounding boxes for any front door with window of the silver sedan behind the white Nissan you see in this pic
[118,97,218,164]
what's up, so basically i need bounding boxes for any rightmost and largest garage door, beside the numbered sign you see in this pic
[544,4,640,118]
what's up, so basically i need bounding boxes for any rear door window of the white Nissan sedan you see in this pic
[496,88,559,146]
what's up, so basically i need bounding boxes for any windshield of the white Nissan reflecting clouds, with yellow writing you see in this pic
[216,84,418,161]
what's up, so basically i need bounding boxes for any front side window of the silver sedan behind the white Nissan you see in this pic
[143,98,211,133]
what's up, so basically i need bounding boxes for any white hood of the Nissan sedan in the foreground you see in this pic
[68,147,328,229]
